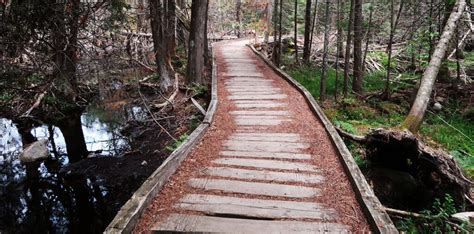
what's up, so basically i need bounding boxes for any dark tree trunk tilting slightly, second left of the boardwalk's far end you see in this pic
[150,1,174,92]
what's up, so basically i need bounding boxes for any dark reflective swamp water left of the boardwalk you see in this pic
[0,107,144,233]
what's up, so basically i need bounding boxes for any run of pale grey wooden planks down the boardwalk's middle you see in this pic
[152,43,356,233]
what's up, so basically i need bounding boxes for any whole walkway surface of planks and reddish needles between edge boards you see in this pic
[135,41,369,232]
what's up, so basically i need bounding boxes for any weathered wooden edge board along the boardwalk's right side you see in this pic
[247,45,398,233]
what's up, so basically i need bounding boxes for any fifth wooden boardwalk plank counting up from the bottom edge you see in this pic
[212,158,319,172]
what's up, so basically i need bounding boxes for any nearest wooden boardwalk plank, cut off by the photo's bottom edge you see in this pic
[152,214,349,233]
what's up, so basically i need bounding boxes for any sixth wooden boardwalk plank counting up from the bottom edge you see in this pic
[219,150,311,160]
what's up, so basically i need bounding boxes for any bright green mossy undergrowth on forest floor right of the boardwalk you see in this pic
[287,65,474,178]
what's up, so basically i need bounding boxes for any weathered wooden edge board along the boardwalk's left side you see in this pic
[104,47,218,233]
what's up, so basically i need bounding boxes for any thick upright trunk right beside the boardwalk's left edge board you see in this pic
[186,0,208,84]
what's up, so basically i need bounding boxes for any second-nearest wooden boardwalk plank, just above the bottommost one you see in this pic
[175,194,337,221]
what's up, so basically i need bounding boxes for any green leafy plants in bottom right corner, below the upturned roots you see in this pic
[396,194,464,233]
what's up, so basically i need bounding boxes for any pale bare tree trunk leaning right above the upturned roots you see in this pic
[402,0,466,133]
